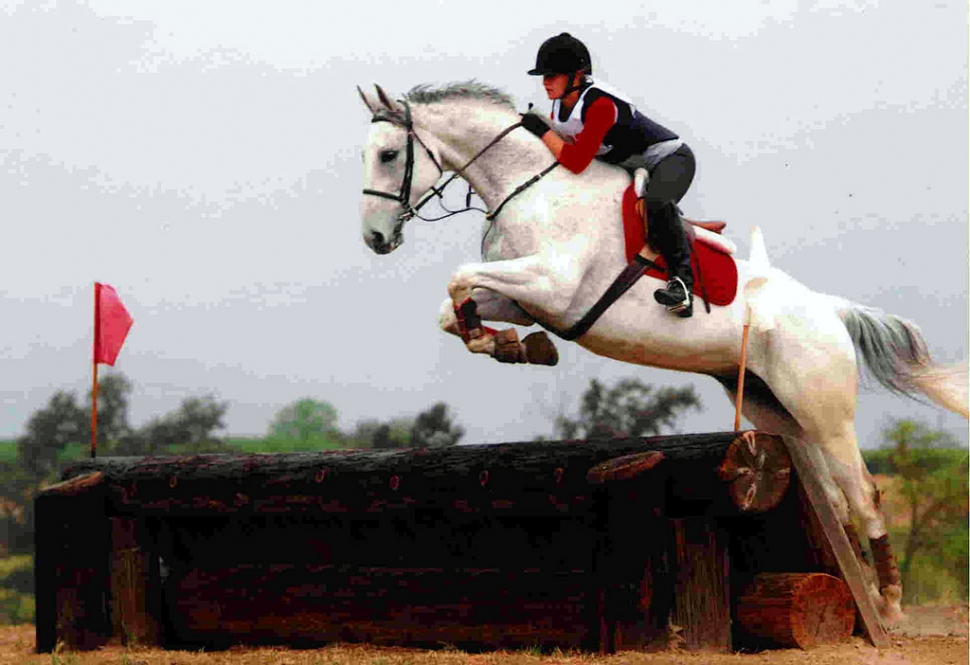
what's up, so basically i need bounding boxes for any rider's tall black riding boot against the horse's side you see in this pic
[650,204,694,318]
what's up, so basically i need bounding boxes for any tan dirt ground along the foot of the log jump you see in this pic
[0,605,970,665]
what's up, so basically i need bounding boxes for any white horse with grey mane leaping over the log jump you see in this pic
[360,82,968,622]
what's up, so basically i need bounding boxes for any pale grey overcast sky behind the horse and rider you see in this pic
[0,0,968,447]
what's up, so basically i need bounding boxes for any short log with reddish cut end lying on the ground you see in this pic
[737,573,855,649]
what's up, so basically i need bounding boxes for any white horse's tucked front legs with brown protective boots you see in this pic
[442,255,578,365]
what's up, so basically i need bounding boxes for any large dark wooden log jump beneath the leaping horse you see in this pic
[36,432,881,653]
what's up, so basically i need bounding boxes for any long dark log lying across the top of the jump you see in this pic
[56,432,788,517]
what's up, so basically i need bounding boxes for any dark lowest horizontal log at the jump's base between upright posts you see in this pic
[163,564,592,649]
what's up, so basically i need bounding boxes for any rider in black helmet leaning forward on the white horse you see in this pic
[522,32,695,318]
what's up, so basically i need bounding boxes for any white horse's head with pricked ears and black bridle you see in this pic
[357,86,441,254]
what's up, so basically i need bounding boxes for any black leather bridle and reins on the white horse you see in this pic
[363,99,532,224]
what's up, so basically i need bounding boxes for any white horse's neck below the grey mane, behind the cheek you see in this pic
[416,103,553,209]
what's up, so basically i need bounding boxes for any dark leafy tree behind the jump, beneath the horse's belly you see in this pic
[555,379,701,439]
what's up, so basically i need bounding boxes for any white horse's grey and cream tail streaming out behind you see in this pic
[838,300,970,418]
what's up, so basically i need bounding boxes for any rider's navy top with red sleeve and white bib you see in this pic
[550,79,678,173]
